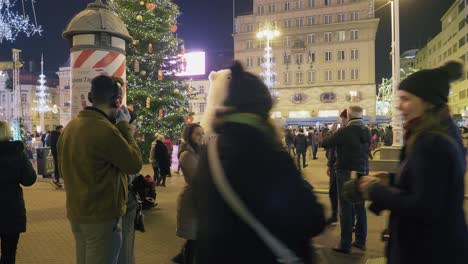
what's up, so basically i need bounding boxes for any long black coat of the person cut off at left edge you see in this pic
[0,141,36,234]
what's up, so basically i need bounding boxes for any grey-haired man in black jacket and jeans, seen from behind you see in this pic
[322,106,371,254]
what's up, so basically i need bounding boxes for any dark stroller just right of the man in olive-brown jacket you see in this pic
[132,174,157,210]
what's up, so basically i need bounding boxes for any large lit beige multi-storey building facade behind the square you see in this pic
[234,0,379,118]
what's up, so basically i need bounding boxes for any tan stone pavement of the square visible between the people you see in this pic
[17,151,466,264]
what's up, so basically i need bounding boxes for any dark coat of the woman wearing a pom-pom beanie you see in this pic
[369,120,468,264]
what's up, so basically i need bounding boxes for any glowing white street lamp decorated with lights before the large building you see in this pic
[257,24,280,98]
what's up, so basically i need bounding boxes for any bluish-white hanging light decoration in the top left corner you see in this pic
[0,0,42,43]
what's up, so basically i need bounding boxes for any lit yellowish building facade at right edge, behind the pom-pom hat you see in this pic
[416,0,468,117]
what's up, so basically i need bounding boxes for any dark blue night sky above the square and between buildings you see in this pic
[0,0,455,83]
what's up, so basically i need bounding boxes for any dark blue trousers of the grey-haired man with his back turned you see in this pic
[336,169,367,249]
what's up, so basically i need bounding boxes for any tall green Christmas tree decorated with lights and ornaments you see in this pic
[108,0,190,161]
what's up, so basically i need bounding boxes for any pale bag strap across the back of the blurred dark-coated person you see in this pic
[208,137,304,264]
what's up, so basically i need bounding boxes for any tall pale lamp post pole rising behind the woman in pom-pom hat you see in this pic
[391,0,403,147]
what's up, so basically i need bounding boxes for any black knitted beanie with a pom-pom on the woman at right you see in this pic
[398,61,464,106]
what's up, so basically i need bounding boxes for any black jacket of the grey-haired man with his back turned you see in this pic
[322,119,371,173]
